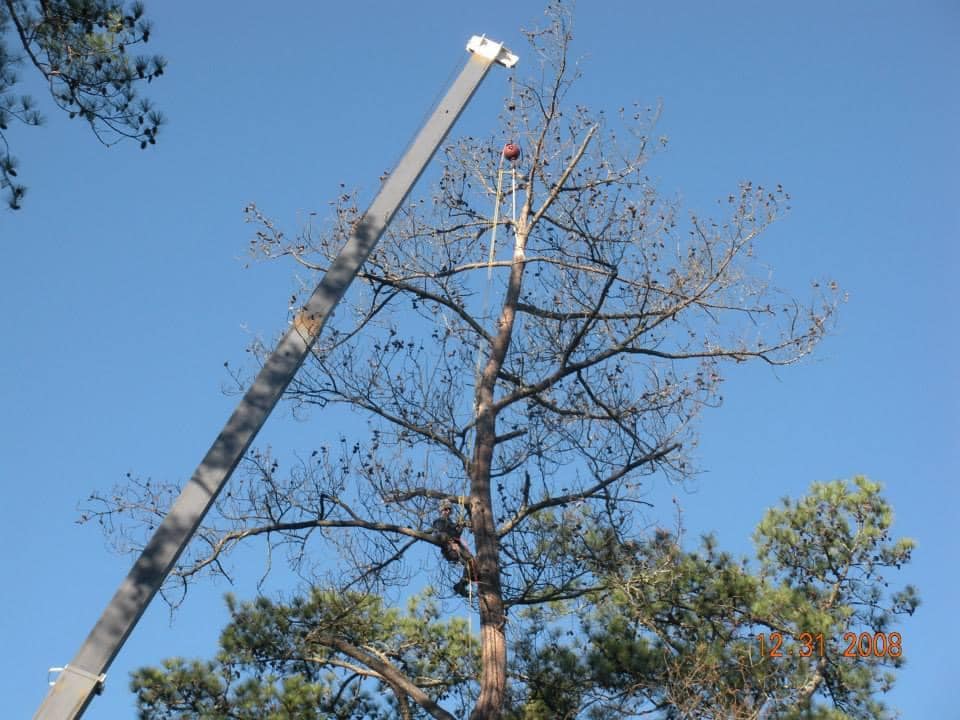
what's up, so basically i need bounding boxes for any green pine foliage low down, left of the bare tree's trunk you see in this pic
[131,589,478,720]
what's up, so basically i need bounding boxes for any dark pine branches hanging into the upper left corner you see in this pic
[0,0,166,209]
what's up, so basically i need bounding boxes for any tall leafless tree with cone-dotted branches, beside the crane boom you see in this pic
[90,8,835,720]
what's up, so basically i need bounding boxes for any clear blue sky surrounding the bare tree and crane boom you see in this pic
[0,0,960,720]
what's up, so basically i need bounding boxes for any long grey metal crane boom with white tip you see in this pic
[34,36,517,720]
